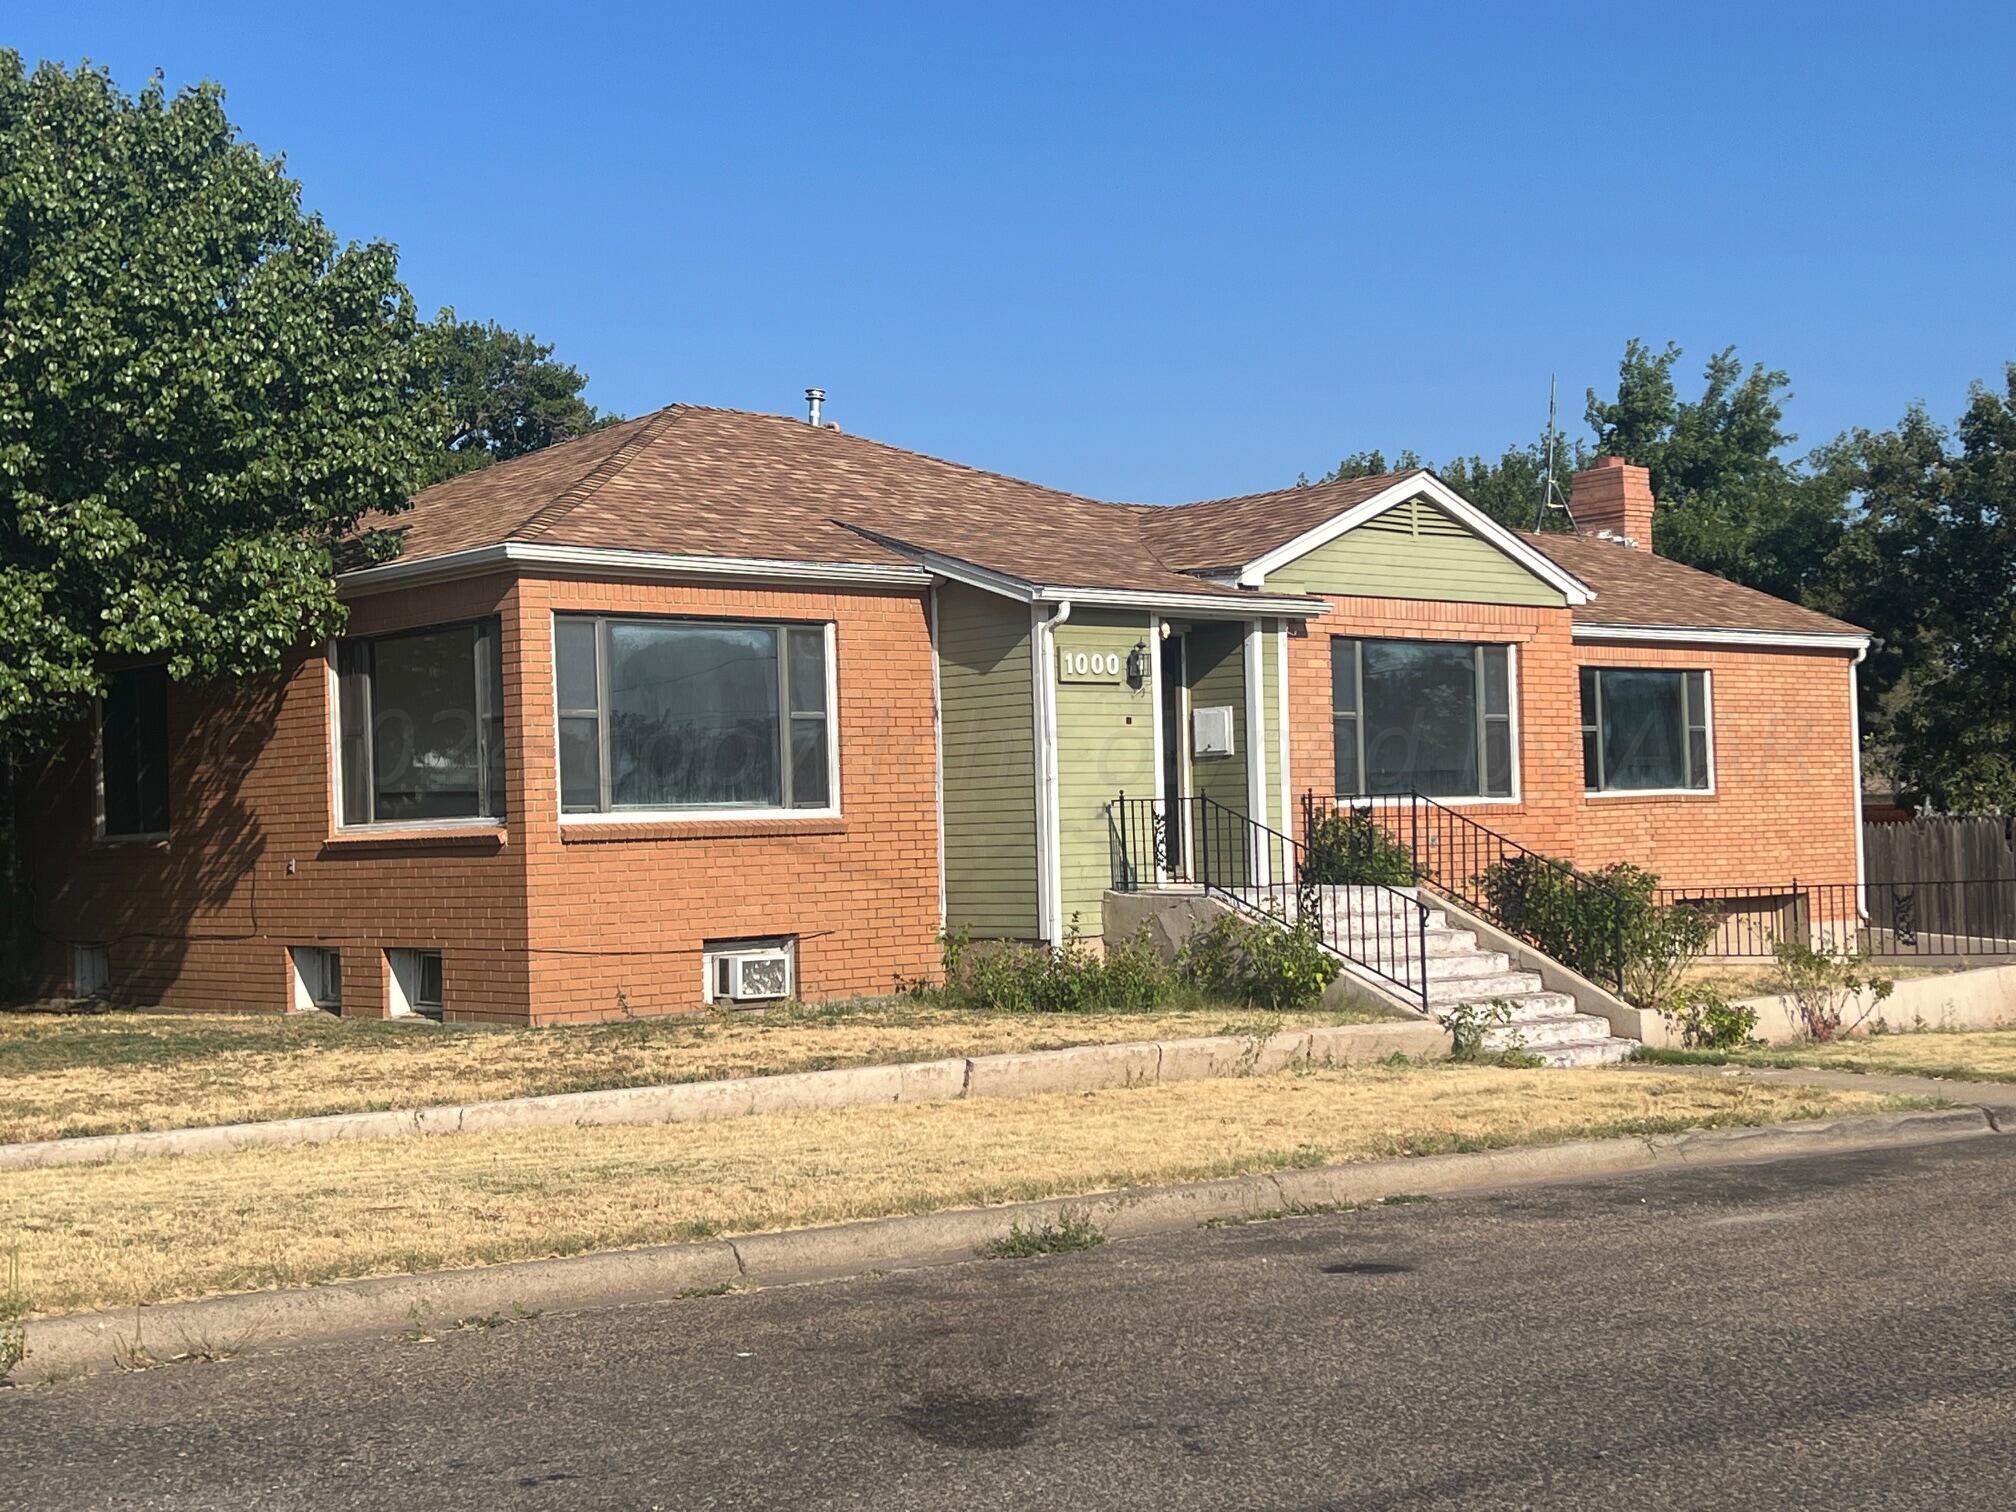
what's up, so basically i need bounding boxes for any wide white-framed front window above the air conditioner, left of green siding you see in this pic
[552,615,839,814]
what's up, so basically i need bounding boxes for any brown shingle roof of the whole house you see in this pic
[358,405,1855,633]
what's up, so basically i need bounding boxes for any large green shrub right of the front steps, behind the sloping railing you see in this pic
[1476,855,1716,1008]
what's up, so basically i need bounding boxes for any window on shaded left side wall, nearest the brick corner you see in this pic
[337,619,504,825]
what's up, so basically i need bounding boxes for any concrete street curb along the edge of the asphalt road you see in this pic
[14,1107,1994,1385]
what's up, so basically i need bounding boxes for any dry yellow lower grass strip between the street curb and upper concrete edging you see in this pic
[0,1064,1899,1312]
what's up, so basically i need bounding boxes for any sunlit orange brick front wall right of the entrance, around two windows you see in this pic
[1288,597,1857,887]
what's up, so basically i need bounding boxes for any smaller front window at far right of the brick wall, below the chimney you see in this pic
[1583,667,1714,792]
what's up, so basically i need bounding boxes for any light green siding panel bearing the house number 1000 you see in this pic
[1054,609,1155,937]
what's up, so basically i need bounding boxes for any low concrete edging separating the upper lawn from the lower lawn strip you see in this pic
[0,1022,1450,1171]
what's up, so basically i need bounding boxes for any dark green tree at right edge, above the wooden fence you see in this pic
[1829,365,2016,812]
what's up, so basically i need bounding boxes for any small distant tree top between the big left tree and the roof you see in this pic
[421,308,617,484]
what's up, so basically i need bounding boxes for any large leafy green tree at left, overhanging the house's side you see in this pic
[0,52,444,744]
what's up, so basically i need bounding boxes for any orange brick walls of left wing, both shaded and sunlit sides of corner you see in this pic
[24,577,937,1022]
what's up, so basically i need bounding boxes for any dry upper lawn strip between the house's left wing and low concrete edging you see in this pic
[0,1000,1371,1143]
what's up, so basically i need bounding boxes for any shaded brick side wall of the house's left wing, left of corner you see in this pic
[15,577,526,1018]
